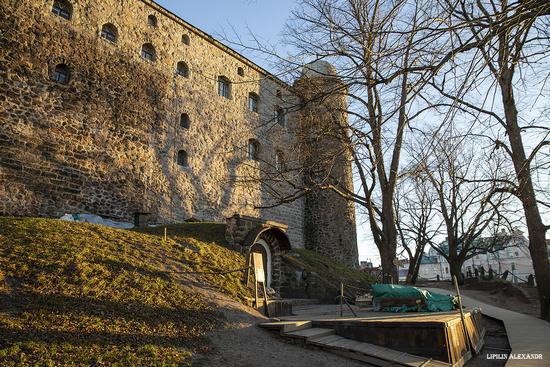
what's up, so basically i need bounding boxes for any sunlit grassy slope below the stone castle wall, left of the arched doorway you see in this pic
[0,217,247,366]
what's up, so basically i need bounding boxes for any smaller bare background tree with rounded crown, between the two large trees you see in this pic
[410,129,508,279]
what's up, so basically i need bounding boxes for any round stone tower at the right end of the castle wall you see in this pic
[294,61,358,267]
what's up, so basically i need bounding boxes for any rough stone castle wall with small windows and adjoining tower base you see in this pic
[0,0,357,266]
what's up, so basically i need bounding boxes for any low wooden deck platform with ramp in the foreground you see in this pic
[260,311,484,367]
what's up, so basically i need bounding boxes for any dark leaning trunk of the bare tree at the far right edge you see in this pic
[499,73,550,321]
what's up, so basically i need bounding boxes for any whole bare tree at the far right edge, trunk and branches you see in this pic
[433,0,550,320]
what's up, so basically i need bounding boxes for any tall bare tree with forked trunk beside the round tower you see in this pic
[274,0,454,282]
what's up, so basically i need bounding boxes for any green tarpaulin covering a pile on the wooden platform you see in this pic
[372,284,457,312]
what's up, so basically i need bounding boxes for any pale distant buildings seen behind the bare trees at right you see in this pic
[399,231,550,282]
